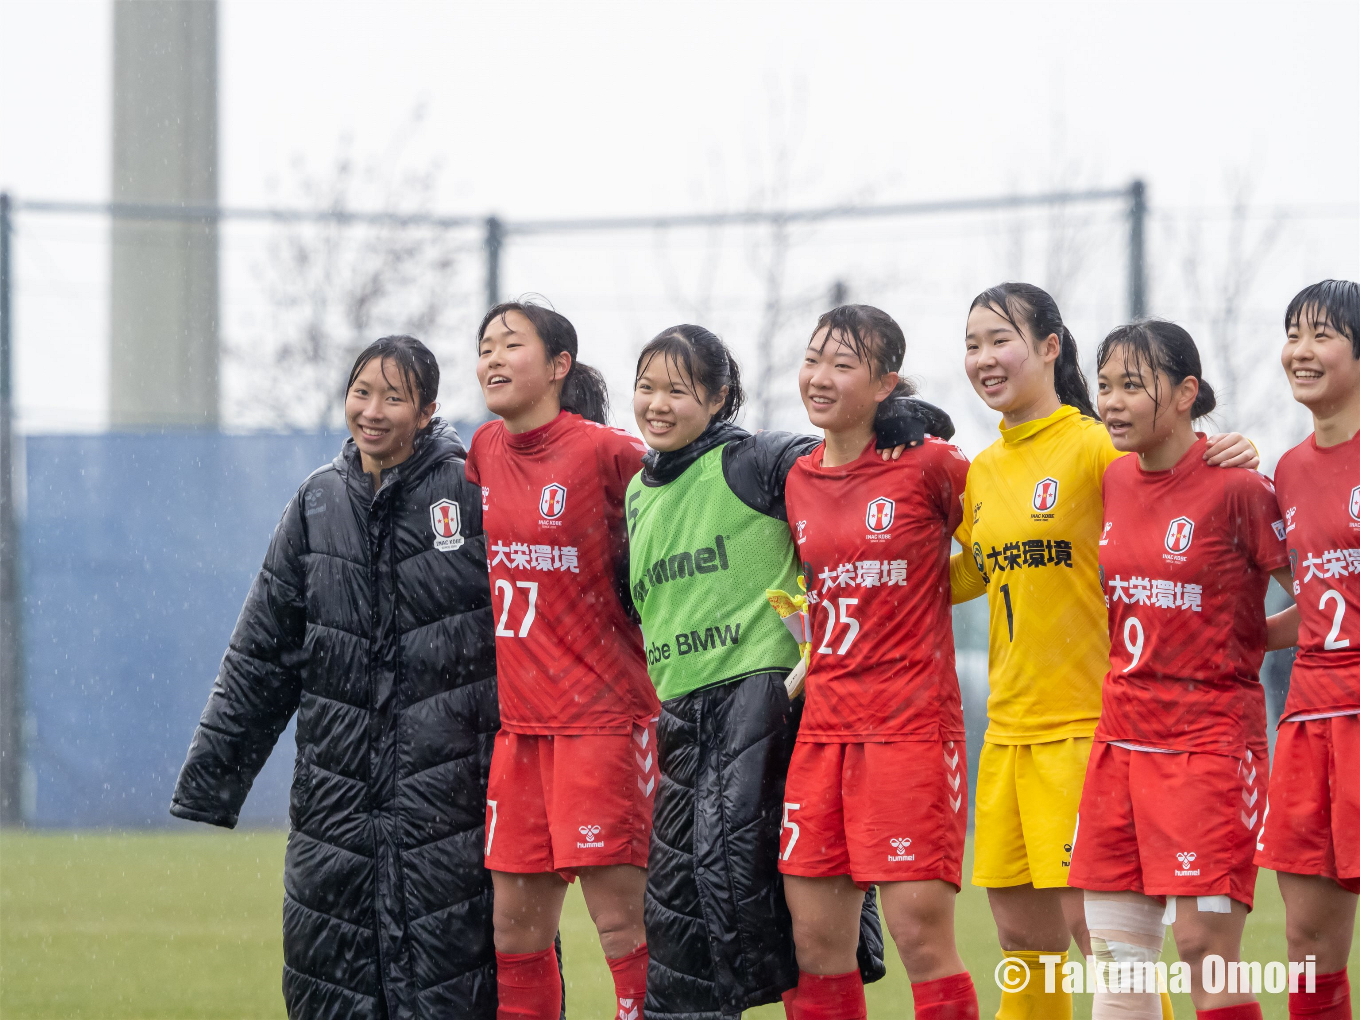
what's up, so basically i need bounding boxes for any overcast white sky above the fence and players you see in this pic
[0,0,1360,454]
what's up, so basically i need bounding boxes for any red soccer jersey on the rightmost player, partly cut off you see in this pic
[1276,435,1360,718]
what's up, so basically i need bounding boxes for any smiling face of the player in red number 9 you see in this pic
[1096,347,1200,453]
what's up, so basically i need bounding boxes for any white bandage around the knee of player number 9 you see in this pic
[1085,892,1167,1020]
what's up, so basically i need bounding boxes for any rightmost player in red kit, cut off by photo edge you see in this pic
[1257,280,1360,1020]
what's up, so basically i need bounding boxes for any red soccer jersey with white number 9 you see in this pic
[1095,437,1289,755]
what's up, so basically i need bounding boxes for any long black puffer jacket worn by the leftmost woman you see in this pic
[170,422,499,1020]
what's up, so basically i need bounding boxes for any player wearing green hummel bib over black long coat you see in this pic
[627,325,948,1020]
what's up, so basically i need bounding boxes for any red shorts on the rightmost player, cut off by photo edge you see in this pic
[1257,715,1360,892]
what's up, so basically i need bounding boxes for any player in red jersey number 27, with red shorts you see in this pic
[468,302,657,1020]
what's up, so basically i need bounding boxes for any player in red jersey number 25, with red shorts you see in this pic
[779,305,978,1020]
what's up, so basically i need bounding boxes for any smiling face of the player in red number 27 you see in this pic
[477,310,571,431]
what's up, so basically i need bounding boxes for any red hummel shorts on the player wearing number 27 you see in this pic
[487,719,657,881]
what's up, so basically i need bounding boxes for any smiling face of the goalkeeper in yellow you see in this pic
[963,305,1062,418]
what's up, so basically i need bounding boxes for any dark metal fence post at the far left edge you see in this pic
[0,194,23,826]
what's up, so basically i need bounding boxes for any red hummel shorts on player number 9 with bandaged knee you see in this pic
[1068,740,1269,907]
